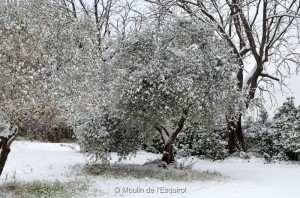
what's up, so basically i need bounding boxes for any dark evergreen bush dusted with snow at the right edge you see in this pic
[244,98,300,161]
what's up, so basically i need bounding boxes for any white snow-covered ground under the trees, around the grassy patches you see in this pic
[0,141,300,198]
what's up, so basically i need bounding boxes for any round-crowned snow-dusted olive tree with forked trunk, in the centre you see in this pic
[99,19,242,164]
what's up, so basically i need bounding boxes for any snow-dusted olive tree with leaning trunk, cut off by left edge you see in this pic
[0,0,91,176]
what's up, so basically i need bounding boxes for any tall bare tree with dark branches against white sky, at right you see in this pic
[146,0,300,153]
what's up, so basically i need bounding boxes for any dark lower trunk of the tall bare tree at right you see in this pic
[227,114,246,154]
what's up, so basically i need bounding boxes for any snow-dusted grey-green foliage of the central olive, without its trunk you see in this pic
[77,17,239,162]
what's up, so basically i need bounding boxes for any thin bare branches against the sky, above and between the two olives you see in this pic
[57,0,144,56]
